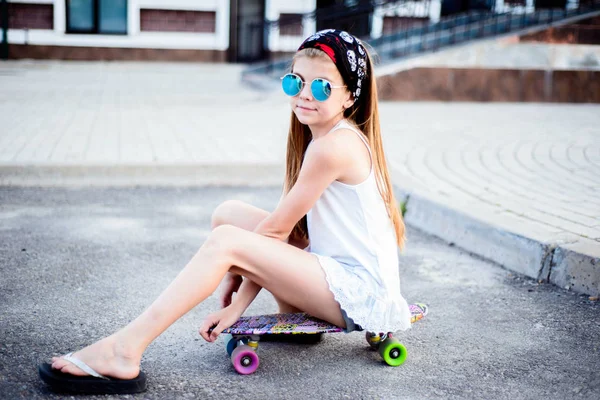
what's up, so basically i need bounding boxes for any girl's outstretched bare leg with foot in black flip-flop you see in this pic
[53,225,345,379]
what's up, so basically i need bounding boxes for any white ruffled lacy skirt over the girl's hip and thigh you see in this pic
[310,252,411,333]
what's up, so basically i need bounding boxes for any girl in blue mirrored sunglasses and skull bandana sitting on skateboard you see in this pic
[39,29,410,393]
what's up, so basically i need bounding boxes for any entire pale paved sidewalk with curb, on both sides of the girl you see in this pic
[0,62,600,294]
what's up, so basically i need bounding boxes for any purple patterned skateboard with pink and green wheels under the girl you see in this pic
[222,304,428,375]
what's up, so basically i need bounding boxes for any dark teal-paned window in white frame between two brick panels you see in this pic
[67,0,127,35]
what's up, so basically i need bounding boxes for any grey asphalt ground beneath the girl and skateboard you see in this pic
[0,187,600,399]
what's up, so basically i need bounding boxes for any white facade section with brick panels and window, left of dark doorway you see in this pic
[2,0,230,61]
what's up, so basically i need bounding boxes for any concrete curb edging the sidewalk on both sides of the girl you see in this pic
[0,163,600,295]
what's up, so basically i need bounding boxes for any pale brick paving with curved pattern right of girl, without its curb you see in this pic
[382,103,600,246]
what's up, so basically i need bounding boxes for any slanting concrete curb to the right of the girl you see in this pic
[396,187,600,296]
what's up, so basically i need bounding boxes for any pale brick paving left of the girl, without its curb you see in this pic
[0,62,287,165]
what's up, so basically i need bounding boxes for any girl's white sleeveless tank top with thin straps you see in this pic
[306,119,401,294]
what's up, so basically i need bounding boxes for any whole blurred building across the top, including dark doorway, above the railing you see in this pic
[0,0,577,62]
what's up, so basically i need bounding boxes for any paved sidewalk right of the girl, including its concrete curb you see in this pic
[382,103,600,294]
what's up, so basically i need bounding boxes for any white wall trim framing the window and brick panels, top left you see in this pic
[8,0,229,50]
